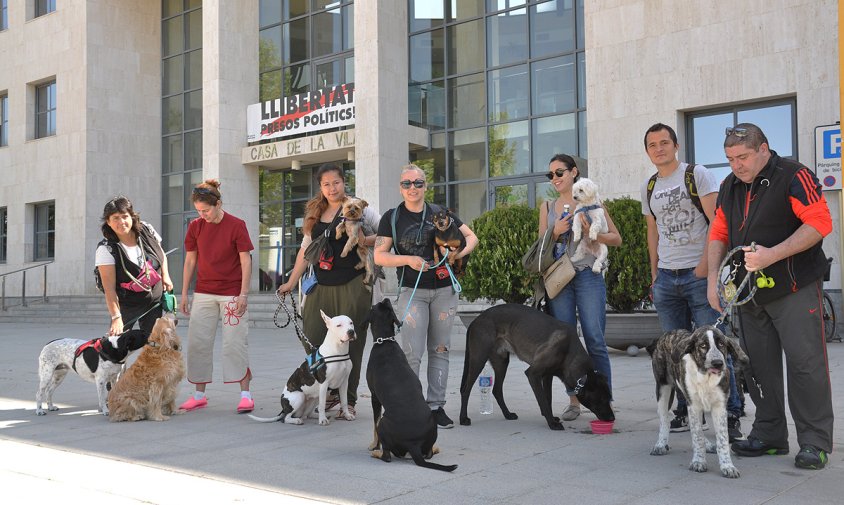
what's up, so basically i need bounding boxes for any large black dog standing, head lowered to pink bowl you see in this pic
[460,303,615,430]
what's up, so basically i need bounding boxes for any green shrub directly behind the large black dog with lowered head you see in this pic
[460,205,539,303]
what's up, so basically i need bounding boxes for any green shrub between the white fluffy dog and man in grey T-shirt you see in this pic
[604,197,651,312]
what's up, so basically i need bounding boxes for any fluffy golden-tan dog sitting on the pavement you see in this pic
[108,316,185,422]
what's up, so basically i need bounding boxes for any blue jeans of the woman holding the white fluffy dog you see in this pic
[549,268,612,395]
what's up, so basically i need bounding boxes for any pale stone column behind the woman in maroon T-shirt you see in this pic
[202,0,258,290]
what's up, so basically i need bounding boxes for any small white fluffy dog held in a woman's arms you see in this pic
[571,178,609,274]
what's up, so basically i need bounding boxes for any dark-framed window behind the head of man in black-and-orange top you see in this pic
[686,98,797,181]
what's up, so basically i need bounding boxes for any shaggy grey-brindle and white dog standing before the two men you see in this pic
[647,326,749,479]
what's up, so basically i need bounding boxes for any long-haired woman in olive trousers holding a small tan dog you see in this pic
[278,163,381,419]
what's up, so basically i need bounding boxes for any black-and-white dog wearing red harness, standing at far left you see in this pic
[35,330,148,416]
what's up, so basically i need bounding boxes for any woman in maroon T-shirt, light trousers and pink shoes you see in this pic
[179,179,255,413]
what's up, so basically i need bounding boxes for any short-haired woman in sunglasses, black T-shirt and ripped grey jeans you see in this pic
[375,165,478,428]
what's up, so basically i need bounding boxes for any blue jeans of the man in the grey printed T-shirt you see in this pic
[653,268,741,416]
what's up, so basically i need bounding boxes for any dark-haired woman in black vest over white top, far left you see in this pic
[95,196,173,335]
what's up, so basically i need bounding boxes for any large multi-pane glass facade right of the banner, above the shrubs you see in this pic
[406,0,587,222]
